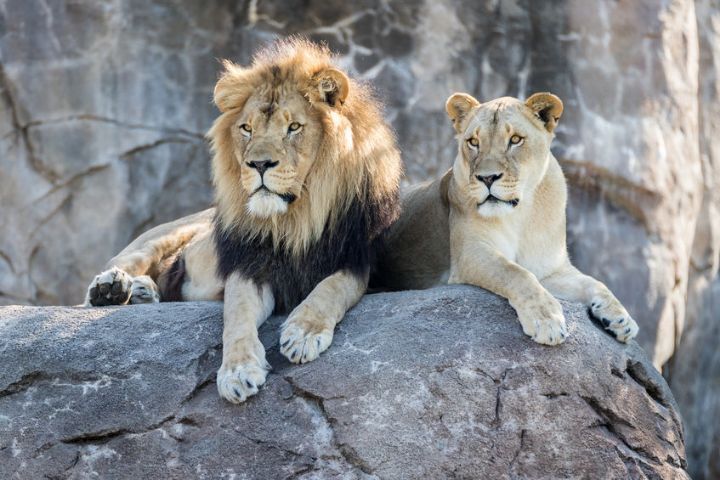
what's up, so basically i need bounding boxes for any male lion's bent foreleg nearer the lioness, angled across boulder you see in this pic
[280,270,368,363]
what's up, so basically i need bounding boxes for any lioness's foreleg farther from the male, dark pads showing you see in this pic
[541,264,638,342]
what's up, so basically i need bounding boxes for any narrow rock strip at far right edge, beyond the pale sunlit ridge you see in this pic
[669,0,720,479]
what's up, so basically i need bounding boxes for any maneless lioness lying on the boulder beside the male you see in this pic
[373,93,638,345]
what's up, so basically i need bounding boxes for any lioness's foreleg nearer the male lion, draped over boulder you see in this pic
[448,248,567,345]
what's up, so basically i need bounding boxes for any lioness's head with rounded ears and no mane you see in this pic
[446,93,562,217]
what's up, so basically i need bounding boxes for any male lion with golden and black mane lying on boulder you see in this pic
[86,40,402,403]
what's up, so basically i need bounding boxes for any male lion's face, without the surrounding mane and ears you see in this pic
[232,91,322,218]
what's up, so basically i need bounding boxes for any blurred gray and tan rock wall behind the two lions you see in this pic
[0,0,720,478]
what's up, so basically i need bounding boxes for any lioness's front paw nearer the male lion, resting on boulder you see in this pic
[516,293,567,345]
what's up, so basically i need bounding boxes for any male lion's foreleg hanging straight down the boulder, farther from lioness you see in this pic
[217,274,275,403]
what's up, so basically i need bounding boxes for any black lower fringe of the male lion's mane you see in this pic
[215,181,400,313]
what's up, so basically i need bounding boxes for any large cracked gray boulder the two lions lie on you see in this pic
[0,286,688,479]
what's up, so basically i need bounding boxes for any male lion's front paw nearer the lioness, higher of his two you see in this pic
[280,305,335,363]
